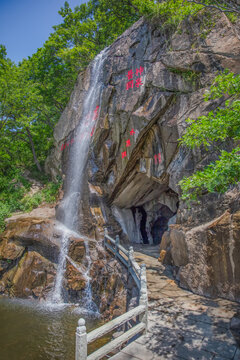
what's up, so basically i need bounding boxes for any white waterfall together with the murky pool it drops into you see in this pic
[0,46,109,360]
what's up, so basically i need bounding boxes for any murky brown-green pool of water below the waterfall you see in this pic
[0,298,107,360]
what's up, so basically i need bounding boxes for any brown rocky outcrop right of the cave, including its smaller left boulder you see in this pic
[160,188,240,301]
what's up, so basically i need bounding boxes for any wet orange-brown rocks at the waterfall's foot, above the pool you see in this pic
[0,214,127,318]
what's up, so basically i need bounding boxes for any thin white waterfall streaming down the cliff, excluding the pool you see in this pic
[50,49,107,312]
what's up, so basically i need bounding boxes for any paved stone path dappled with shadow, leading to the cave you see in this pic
[111,245,240,360]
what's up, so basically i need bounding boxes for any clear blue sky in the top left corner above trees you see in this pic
[0,0,87,62]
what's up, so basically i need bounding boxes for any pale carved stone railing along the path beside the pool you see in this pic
[75,232,148,360]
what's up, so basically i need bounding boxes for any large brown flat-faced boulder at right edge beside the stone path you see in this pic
[176,211,240,301]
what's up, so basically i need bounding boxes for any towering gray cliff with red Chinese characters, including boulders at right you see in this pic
[46,13,240,300]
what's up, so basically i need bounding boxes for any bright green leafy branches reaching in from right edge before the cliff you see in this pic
[180,71,240,200]
